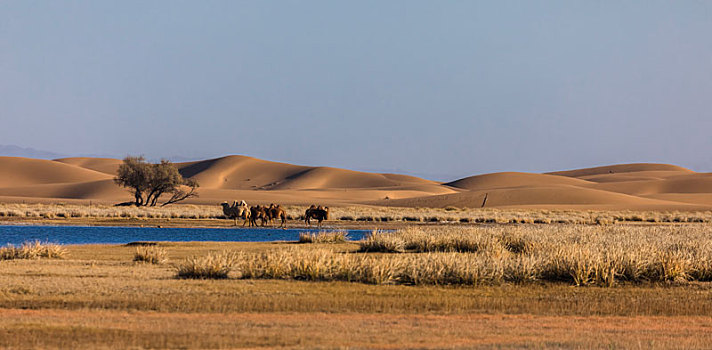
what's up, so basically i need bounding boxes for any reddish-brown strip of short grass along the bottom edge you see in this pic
[0,310,712,349]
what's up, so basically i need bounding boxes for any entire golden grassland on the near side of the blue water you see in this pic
[0,224,712,349]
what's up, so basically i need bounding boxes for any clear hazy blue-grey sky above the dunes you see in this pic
[0,0,712,181]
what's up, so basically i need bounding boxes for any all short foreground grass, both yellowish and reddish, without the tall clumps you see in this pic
[0,239,712,349]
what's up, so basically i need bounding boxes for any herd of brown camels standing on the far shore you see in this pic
[220,200,329,227]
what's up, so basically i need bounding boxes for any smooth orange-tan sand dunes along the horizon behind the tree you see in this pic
[0,156,712,210]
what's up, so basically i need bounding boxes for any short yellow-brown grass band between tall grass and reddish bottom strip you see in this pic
[0,247,712,317]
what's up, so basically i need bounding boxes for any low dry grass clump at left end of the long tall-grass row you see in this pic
[175,251,239,279]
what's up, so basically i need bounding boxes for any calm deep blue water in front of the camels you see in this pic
[0,225,370,245]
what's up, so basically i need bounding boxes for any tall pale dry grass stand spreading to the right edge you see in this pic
[231,225,712,287]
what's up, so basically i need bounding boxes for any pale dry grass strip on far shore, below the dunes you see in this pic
[0,203,712,226]
